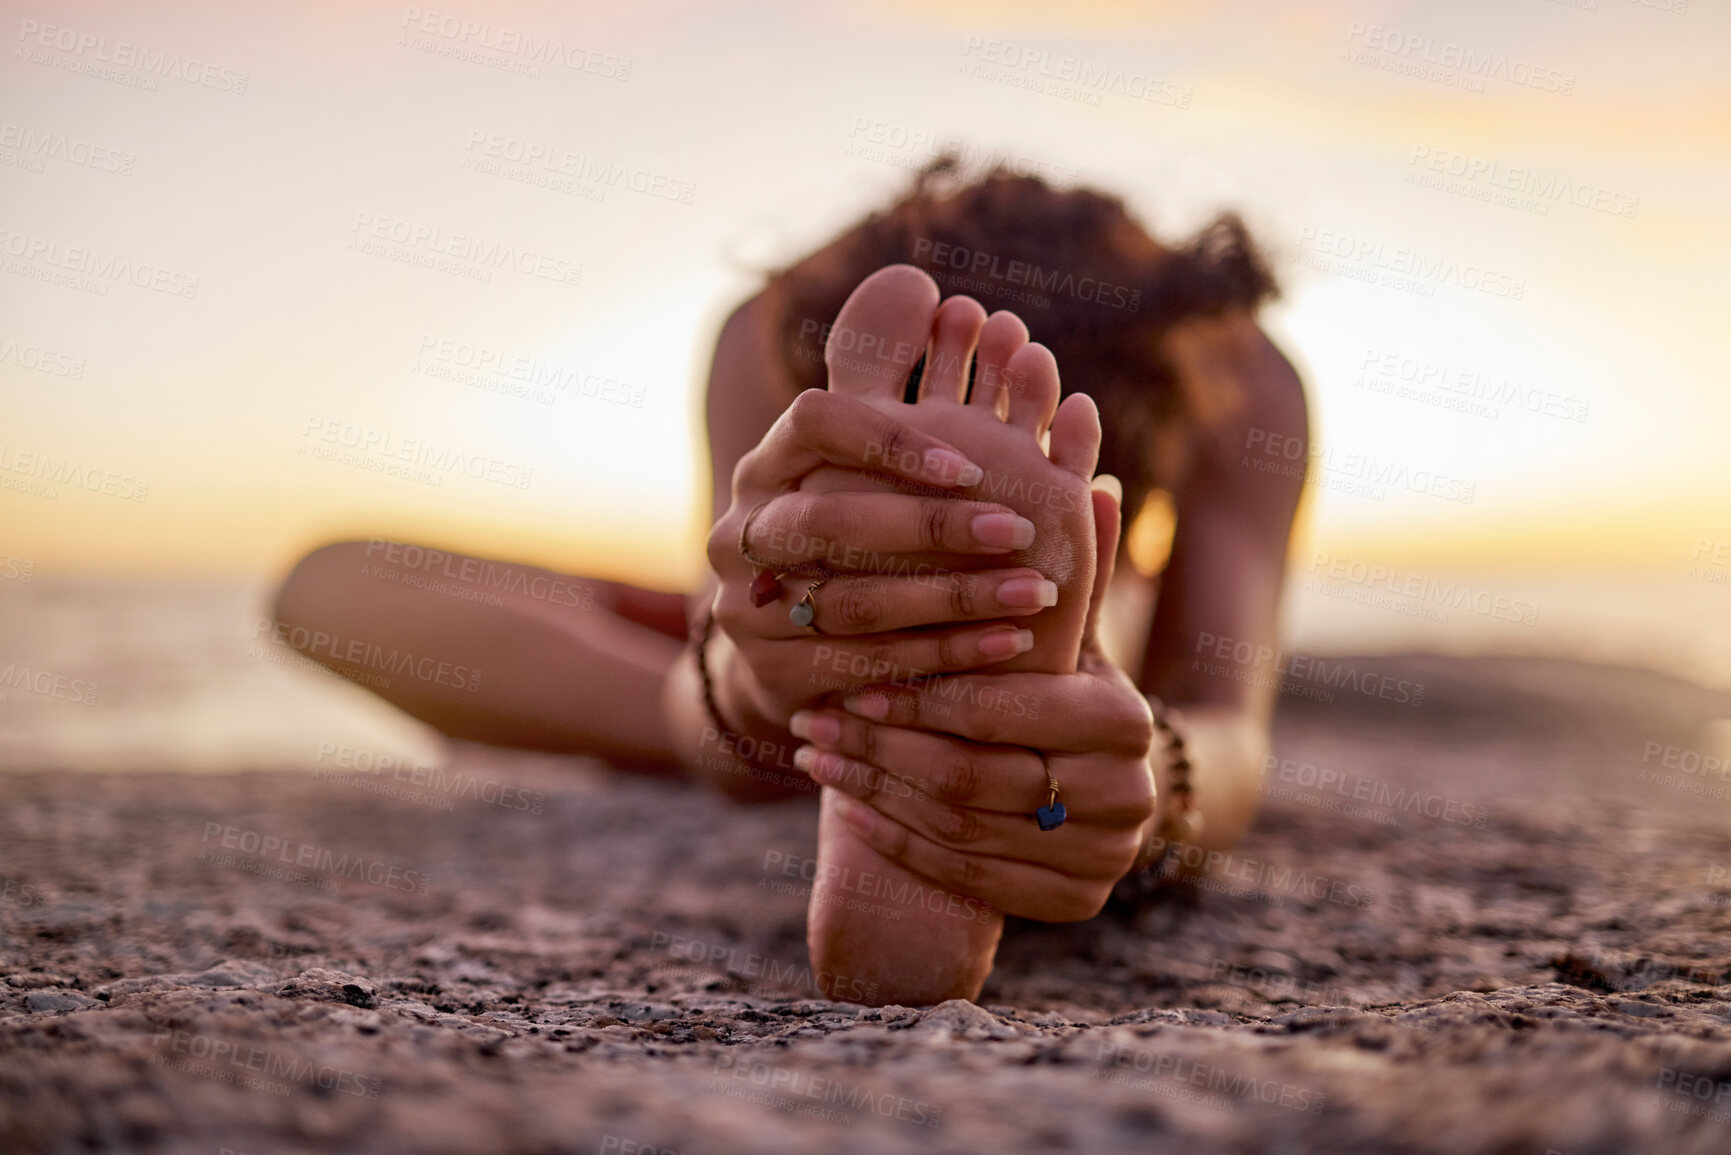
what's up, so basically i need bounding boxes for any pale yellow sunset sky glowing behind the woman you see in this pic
[0,0,1731,587]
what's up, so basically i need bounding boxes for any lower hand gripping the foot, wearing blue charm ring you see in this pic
[778,490,1155,921]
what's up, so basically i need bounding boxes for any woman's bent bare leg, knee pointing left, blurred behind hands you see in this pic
[275,542,685,774]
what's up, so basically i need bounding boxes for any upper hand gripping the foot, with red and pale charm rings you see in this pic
[708,390,1058,727]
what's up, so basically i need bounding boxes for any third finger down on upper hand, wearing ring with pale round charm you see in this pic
[781,563,1058,637]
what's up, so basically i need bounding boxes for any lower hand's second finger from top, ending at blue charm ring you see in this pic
[788,710,1047,814]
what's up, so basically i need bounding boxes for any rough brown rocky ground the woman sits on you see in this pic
[0,581,1731,1155]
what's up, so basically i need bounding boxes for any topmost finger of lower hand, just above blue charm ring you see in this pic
[841,674,1155,757]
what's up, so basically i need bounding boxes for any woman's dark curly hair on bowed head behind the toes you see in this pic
[763,154,1279,516]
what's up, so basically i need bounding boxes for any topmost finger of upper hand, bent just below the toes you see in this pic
[734,390,985,494]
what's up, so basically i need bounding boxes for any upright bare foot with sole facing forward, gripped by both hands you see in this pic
[801,265,1099,1004]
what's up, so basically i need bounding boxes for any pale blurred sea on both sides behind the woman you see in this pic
[0,575,1731,772]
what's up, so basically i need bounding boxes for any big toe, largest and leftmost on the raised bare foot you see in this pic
[824,265,938,402]
